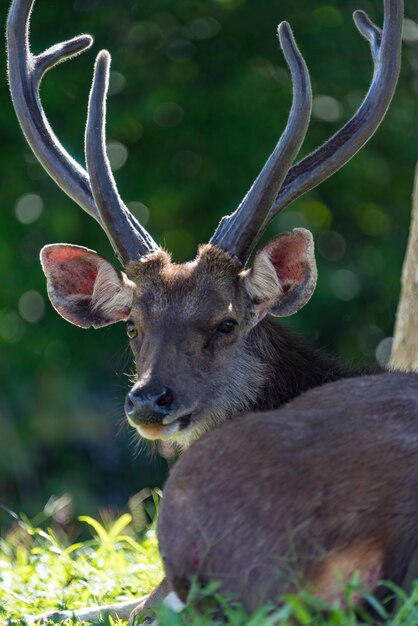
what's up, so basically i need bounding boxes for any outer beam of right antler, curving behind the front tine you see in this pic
[263,0,403,223]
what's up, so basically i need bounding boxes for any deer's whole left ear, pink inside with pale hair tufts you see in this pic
[41,243,134,328]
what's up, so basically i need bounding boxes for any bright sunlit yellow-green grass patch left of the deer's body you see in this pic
[0,514,163,623]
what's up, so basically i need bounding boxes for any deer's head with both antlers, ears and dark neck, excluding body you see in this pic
[7,0,403,620]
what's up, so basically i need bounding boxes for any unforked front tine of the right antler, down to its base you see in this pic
[210,22,312,264]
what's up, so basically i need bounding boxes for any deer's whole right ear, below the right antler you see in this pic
[245,228,317,320]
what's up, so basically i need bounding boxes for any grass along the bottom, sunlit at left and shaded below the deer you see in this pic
[0,502,418,626]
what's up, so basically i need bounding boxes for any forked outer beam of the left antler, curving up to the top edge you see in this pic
[7,0,159,263]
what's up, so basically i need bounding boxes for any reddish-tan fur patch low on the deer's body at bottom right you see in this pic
[312,540,384,604]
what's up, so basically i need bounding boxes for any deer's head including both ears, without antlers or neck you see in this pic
[41,229,316,446]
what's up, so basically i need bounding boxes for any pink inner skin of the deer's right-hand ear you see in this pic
[265,232,309,290]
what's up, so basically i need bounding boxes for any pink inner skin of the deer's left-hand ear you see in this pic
[42,245,98,296]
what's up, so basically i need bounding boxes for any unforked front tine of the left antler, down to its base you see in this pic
[85,50,159,265]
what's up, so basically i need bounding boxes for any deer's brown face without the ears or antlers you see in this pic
[125,246,262,443]
